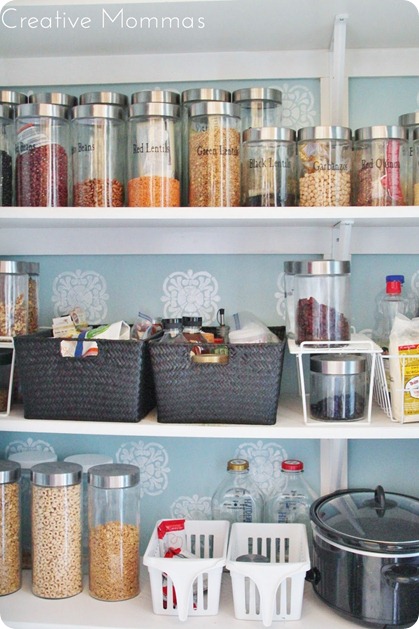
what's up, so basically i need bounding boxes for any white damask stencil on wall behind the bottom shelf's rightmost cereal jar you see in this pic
[115,441,170,496]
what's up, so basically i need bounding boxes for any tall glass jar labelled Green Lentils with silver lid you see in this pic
[188,102,240,207]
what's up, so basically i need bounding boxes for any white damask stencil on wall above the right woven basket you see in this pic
[161,270,220,325]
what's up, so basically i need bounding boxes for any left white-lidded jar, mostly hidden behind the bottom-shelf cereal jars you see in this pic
[9,450,57,569]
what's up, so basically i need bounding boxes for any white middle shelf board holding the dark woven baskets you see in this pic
[0,395,419,439]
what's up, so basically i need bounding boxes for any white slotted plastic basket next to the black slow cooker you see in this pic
[226,523,310,627]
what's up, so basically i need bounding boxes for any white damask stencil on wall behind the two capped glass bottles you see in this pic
[235,441,288,495]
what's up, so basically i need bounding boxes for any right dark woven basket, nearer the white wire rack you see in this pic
[150,327,285,424]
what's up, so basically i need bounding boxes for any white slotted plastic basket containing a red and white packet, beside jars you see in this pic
[144,520,230,620]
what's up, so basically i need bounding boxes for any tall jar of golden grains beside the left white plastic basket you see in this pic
[88,463,140,601]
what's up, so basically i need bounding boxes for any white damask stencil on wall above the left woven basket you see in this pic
[52,269,109,324]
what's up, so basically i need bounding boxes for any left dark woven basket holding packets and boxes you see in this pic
[15,331,155,422]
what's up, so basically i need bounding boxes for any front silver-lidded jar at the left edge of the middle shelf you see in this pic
[0,260,28,336]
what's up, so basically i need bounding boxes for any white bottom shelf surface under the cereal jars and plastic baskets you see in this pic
[0,566,360,629]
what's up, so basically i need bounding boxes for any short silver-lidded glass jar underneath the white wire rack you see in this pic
[310,354,367,421]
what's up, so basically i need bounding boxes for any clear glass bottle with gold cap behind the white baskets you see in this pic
[211,459,263,523]
